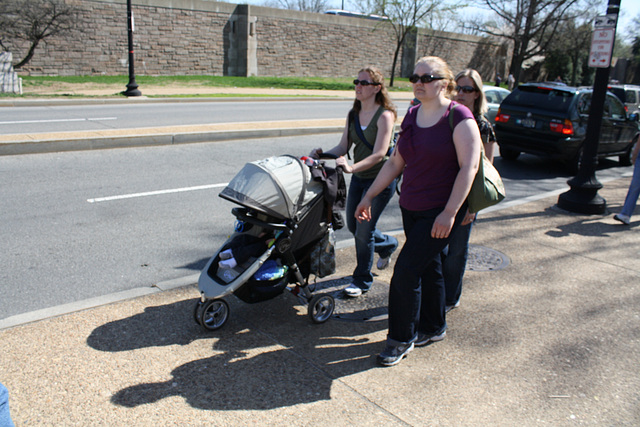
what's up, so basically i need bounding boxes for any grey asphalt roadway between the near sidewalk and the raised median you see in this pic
[0,134,631,319]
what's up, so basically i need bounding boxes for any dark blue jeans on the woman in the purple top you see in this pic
[387,205,466,345]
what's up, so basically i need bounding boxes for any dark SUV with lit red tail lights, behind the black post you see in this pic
[495,83,638,173]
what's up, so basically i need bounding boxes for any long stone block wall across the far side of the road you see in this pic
[1,0,506,80]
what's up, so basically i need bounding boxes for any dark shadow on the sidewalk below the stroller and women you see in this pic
[87,287,387,410]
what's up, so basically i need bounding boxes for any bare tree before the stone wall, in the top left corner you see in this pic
[0,0,79,69]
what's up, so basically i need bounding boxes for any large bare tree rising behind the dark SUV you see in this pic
[470,0,579,82]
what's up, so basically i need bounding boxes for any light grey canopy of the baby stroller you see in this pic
[220,155,323,220]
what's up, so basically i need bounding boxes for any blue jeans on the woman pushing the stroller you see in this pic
[346,175,398,291]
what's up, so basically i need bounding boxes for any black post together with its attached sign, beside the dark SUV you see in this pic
[558,0,620,214]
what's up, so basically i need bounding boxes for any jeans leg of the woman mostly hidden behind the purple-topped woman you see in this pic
[441,222,473,305]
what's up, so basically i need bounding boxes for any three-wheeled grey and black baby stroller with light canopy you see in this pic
[194,155,346,330]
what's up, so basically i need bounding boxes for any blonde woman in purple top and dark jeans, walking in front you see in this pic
[355,56,481,366]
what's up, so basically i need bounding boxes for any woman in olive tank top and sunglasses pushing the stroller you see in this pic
[310,67,398,297]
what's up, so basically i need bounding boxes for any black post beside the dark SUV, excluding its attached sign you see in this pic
[558,0,620,214]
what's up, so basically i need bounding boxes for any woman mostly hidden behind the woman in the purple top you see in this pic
[442,69,496,312]
